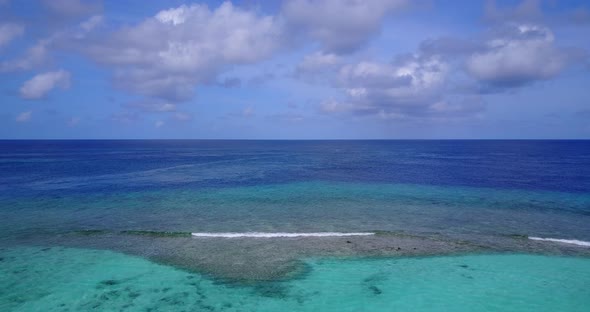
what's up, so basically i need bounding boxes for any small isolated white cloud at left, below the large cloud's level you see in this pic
[20,70,70,99]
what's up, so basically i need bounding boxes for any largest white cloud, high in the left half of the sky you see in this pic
[87,2,282,101]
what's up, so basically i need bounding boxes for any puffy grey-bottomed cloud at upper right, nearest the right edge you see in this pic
[466,25,566,86]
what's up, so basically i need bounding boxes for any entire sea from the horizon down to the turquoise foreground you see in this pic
[0,140,590,312]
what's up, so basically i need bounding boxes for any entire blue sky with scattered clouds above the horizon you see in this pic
[0,0,590,139]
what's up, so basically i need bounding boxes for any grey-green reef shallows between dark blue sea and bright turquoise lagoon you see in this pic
[0,181,590,280]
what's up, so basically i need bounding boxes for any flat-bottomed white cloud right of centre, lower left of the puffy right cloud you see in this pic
[319,55,485,119]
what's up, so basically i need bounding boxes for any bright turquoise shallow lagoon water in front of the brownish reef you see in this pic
[0,247,590,312]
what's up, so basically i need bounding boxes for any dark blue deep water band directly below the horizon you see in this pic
[0,140,590,195]
